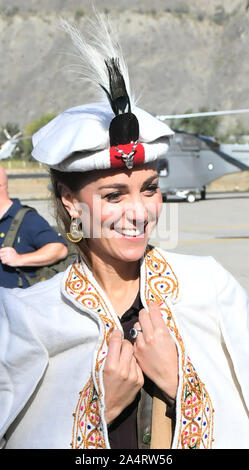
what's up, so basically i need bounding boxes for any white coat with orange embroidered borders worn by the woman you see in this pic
[0,249,249,449]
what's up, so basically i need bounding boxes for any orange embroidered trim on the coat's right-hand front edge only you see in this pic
[145,248,214,449]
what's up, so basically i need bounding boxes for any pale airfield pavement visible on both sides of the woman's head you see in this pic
[23,193,249,294]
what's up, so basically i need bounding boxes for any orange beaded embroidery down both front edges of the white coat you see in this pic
[66,248,214,449]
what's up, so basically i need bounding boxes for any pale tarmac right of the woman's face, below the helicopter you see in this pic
[155,193,249,293]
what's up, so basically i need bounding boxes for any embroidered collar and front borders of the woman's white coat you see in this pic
[62,247,214,449]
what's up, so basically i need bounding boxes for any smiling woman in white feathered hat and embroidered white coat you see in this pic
[0,12,249,448]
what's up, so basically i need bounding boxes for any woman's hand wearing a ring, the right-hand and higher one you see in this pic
[134,304,178,398]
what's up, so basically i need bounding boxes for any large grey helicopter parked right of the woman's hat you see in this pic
[156,109,249,202]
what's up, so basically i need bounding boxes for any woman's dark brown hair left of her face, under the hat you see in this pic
[50,168,91,266]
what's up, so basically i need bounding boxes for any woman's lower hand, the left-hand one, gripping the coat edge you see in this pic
[103,330,144,425]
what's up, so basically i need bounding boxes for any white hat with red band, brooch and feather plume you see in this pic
[32,16,174,172]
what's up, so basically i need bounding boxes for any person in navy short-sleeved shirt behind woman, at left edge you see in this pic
[0,166,68,288]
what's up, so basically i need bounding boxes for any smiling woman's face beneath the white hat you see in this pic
[62,165,162,261]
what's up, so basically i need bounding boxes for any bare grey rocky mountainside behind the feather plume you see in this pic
[0,0,249,132]
